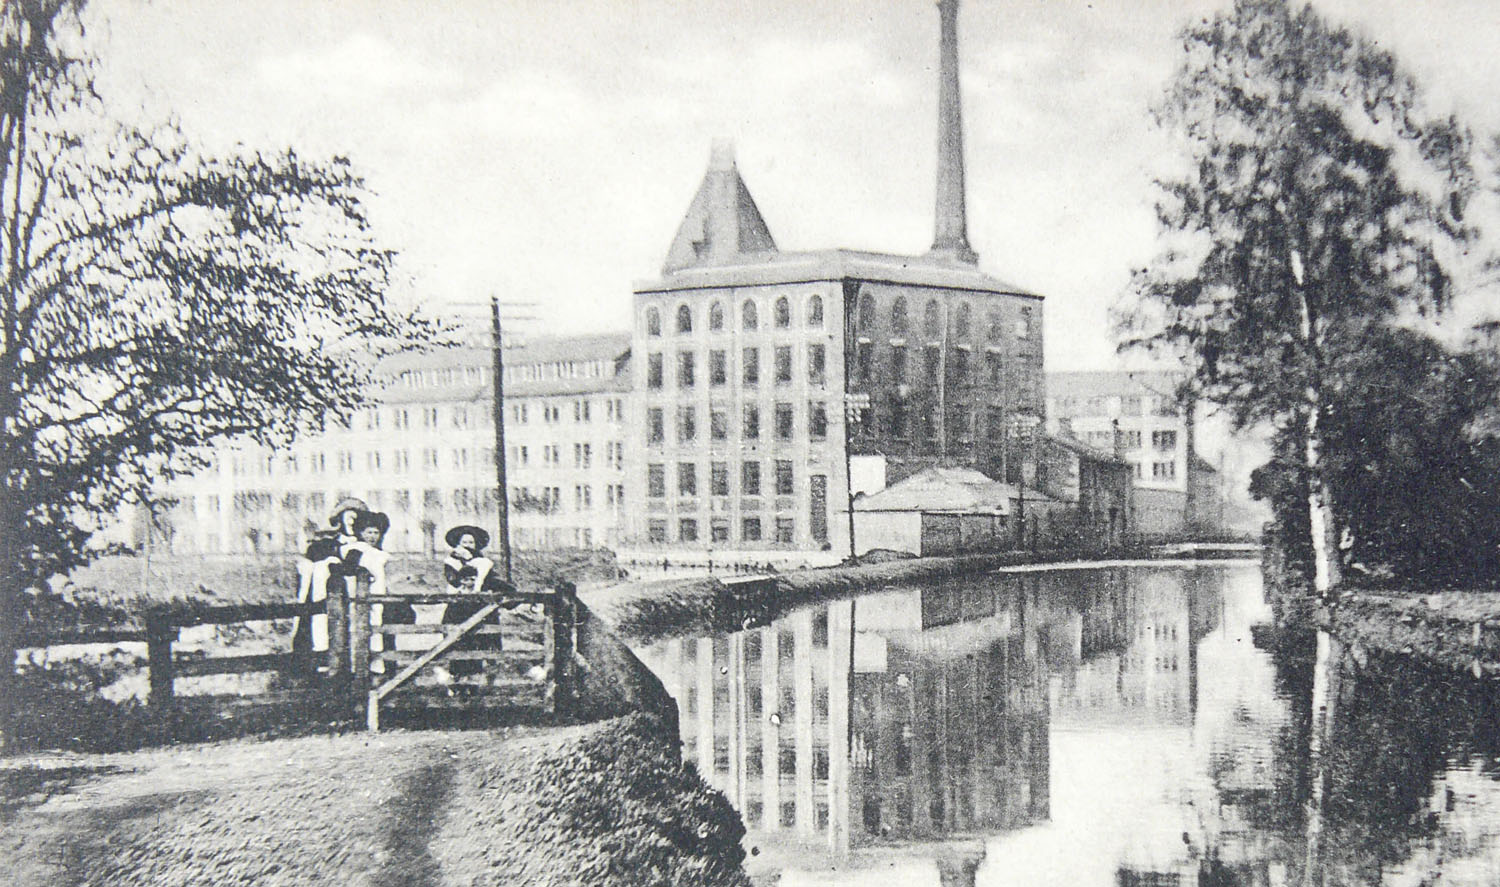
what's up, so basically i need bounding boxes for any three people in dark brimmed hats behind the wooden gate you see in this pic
[293,498,509,651]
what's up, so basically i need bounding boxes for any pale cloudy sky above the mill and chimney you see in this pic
[90,0,1500,369]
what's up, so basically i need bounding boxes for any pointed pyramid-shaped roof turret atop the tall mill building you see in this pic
[662,141,776,273]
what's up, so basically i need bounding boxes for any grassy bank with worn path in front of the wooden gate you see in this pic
[0,714,747,887]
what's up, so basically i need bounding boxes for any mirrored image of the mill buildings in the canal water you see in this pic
[644,570,1217,884]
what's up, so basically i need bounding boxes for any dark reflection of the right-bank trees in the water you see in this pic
[1248,629,1500,885]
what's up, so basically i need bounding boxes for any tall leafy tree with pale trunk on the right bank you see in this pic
[1121,0,1475,597]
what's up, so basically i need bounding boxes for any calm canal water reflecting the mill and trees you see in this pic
[627,566,1500,887]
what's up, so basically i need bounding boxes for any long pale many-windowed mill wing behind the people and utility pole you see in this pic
[159,333,630,554]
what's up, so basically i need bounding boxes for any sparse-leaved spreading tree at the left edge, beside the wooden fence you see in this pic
[0,0,438,750]
